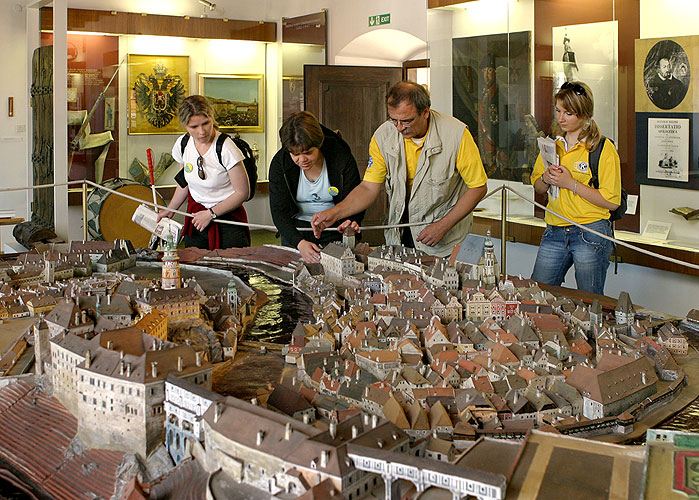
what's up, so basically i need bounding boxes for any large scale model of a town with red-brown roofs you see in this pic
[0,235,699,500]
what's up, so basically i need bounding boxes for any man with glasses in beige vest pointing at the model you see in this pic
[311,81,488,257]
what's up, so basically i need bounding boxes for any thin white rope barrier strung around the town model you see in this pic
[0,179,699,270]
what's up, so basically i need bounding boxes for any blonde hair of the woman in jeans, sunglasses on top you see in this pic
[551,82,602,151]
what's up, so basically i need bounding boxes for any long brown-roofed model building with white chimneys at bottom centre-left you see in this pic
[203,397,408,499]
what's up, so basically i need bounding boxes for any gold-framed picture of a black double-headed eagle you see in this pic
[128,54,189,134]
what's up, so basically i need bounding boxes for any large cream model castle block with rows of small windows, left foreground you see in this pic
[51,327,211,457]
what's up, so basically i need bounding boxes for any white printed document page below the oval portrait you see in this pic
[648,118,689,182]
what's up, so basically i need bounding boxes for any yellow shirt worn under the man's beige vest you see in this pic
[364,128,488,192]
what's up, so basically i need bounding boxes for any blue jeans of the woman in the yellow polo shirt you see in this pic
[532,220,614,295]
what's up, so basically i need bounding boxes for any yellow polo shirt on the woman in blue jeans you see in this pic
[531,137,621,226]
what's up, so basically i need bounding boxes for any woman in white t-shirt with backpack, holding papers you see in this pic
[158,95,250,250]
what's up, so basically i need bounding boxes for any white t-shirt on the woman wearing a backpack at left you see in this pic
[172,131,244,208]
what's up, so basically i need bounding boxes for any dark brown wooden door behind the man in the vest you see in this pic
[303,65,402,245]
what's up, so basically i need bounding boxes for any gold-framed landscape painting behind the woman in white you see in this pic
[198,73,264,132]
